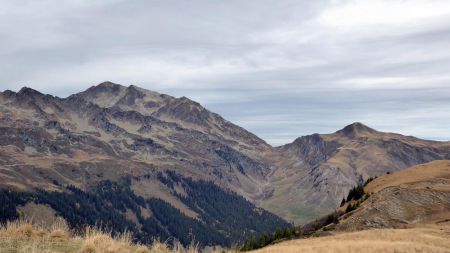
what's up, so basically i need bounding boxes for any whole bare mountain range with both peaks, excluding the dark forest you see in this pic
[0,82,450,229]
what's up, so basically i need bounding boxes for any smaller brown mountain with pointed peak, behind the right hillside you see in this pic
[260,123,450,222]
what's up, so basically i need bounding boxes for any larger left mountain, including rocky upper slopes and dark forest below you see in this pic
[0,82,289,245]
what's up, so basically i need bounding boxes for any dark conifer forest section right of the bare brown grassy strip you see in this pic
[158,171,292,245]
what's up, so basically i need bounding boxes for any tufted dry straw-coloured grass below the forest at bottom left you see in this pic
[0,220,230,253]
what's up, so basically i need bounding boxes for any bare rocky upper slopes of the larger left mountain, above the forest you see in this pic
[0,83,270,198]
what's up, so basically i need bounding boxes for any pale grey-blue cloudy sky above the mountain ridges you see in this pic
[0,0,450,145]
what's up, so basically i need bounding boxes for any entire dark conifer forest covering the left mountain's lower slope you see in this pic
[0,172,290,246]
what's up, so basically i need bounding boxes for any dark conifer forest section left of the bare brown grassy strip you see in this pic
[0,181,224,245]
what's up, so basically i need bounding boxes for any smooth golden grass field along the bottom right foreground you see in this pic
[250,225,450,253]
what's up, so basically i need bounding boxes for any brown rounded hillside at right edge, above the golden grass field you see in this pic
[337,161,450,231]
